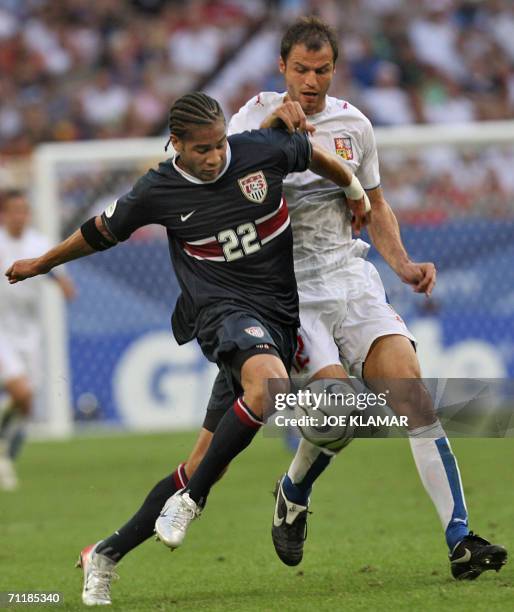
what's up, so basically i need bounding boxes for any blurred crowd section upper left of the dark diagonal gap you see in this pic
[0,0,262,154]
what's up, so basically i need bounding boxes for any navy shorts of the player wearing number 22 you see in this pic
[197,309,297,431]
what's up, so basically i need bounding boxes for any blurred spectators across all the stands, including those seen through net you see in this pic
[0,0,514,215]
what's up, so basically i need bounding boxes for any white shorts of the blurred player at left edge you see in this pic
[0,333,41,387]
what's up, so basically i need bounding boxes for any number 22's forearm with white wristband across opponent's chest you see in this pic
[309,143,371,235]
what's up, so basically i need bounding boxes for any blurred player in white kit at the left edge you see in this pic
[0,191,74,490]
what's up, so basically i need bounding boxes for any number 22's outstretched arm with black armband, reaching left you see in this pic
[5,217,115,285]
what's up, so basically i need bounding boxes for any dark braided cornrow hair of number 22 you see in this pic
[168,91,225,138]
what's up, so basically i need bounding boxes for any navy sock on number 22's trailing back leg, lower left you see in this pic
[96,463,188,563]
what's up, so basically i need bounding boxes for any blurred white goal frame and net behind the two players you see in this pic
[34,123,514,434]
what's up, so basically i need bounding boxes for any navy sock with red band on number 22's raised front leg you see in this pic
[187,398,262,506]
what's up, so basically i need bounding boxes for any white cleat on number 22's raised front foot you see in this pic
[155,490,200,550]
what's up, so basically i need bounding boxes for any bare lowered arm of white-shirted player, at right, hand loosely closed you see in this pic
[368,187,436,296]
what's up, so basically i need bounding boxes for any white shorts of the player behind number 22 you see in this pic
[292,257,416,381]
